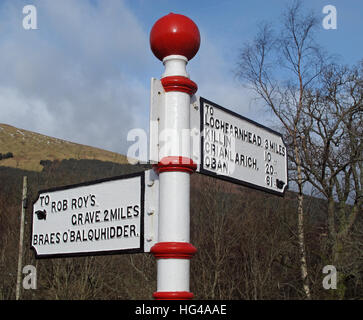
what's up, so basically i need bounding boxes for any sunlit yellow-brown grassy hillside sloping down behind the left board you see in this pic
[0,123,127,171]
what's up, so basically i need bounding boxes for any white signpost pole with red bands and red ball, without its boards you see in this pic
[150,13,200,300]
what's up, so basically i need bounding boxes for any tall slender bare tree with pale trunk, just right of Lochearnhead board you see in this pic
[237,1,324,299]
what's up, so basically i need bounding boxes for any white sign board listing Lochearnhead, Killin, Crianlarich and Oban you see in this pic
[190,97,288,195]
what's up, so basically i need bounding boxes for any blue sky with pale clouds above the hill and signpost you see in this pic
[0,0,363,154]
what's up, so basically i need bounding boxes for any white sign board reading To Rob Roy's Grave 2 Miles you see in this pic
[31,170,159,257]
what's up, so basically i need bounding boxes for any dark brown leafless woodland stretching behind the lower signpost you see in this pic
[0,160,363,300]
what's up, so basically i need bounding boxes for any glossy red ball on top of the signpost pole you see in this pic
[150,13,200,61]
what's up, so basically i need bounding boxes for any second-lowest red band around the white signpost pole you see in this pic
[150,242,197,259]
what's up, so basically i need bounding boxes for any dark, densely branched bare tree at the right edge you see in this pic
[298,64,363,298]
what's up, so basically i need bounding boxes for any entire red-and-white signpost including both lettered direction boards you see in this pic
[31,13,288,299]
